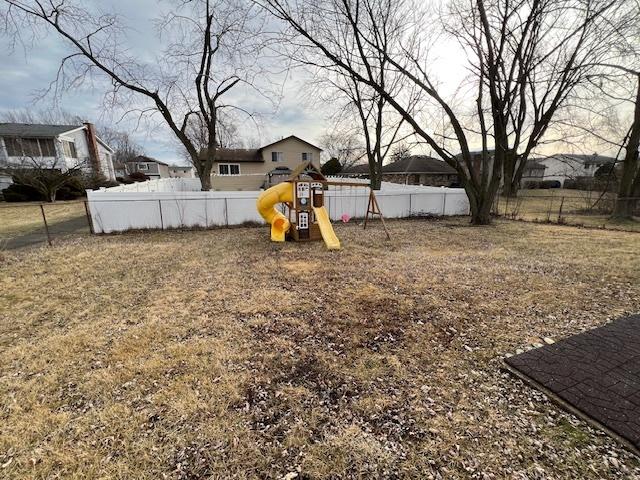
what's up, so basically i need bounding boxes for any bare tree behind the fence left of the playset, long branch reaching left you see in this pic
[0,0,273,190]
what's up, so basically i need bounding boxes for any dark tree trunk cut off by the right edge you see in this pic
[612,76,640,219]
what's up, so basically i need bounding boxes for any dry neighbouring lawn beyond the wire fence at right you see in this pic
[496,189,640,232]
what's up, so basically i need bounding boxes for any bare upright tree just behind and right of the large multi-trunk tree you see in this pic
[446,0,637,196]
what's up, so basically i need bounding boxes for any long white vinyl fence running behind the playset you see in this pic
[87,179,469,233]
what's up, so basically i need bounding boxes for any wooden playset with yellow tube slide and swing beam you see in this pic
[256,162,390,250]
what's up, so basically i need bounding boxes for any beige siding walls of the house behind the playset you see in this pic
[211,138,321,190]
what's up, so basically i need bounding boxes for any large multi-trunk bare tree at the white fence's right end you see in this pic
[259,0,636,224]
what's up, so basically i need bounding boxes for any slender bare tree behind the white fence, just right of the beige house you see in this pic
[280,2,420,190]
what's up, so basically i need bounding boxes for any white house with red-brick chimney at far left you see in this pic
[0,123,116,188]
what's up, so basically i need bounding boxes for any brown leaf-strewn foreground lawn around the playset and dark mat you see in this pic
[0,219,640,479]
